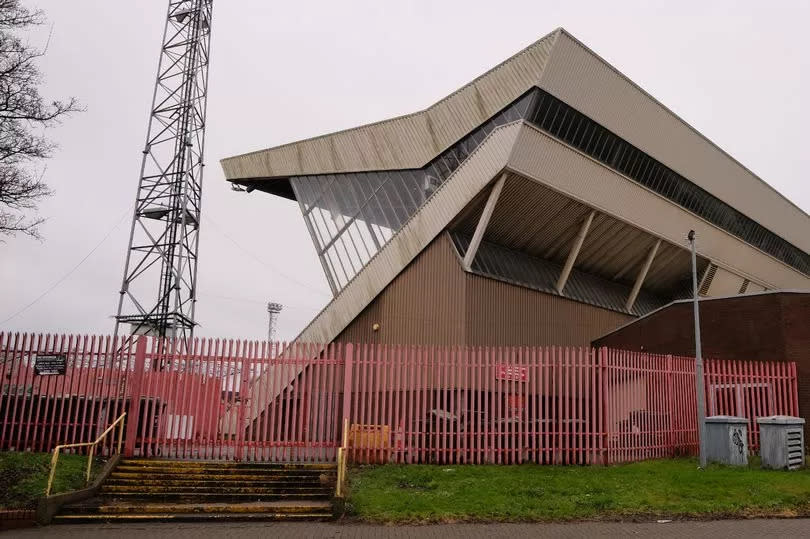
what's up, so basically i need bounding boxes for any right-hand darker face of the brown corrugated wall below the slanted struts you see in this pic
[465,274,634,346]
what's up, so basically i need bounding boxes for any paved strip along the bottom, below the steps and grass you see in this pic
[0,519,810,539]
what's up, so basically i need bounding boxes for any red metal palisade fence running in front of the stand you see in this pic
[0,334,798,464]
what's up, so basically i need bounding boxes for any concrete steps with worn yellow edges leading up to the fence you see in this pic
[54,459,336,523]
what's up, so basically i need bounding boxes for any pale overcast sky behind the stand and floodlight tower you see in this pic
[0,0,810,339]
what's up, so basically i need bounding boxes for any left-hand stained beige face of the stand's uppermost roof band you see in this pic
[220,30,559,180]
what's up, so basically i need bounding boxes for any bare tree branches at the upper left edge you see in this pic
[0,0,80,238]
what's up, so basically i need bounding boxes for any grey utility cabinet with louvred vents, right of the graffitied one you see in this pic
[757,415,804,470]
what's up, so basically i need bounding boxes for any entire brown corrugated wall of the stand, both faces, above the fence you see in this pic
[336,234,633,345]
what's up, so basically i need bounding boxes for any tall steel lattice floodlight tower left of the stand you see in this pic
[115,0,213,338]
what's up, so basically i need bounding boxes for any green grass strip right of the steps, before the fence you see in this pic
[346,459,810,523]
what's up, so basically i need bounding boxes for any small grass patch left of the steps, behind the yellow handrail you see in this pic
[0,452,101,509]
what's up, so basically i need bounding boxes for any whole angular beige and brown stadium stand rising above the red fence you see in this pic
[222,29,810,345]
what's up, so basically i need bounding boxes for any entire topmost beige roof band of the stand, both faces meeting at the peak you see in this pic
[221,29,810,252]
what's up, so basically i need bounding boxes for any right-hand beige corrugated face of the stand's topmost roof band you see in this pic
[539,31,810,252]
